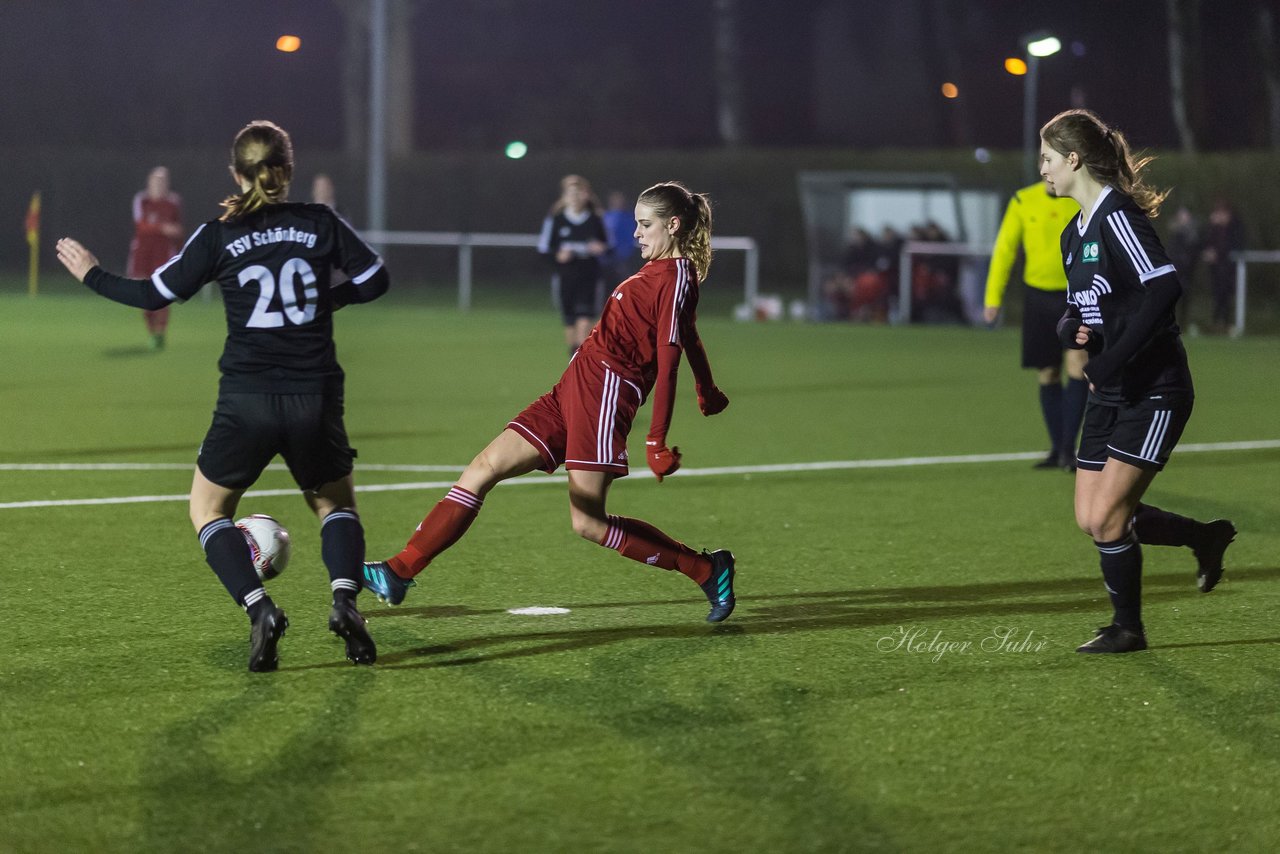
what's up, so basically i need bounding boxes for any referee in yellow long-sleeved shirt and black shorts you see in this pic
[983,182,1089,471]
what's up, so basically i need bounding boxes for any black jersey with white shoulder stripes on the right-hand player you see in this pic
[1062,187,1193,408]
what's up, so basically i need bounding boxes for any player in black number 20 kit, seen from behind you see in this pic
[58,122,389,671]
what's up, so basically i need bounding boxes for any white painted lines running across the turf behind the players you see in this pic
[0,439,1280,510]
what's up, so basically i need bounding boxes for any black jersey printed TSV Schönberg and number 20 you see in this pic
[151,204,383,394]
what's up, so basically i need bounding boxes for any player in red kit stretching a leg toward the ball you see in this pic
[364,182,735,622]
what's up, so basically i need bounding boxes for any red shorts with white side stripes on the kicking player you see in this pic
[507,359,641,478]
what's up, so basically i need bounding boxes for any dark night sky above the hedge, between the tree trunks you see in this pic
[0,0,1271,150]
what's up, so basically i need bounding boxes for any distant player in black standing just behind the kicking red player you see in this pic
[538,175,609,356]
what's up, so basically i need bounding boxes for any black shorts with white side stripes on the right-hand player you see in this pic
[1075,401,1192,471]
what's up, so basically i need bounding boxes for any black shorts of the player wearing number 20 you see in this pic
[196,392,356,490]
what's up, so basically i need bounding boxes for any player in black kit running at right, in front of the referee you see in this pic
[1041,110,1235,653]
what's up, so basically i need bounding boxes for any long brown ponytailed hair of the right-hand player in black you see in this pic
[1041,110,1169,216]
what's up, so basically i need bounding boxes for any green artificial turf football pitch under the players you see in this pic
[0,286,1280,853]
